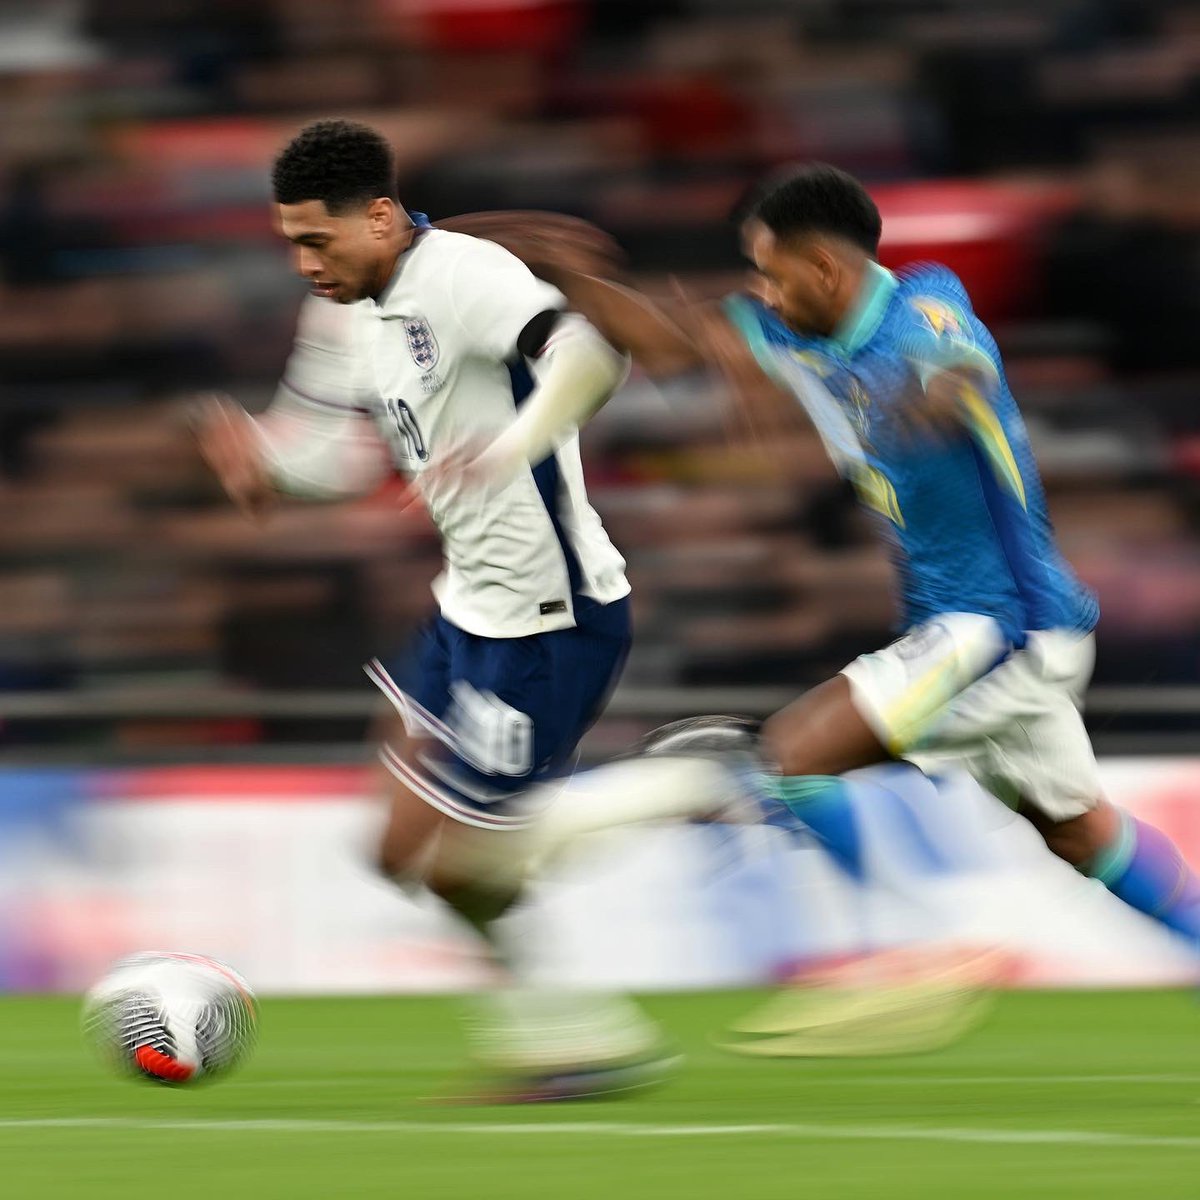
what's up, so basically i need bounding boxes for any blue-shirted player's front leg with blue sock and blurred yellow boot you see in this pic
[720,614,1022,1055]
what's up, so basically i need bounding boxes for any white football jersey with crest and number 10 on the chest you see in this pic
[262,229,629,637]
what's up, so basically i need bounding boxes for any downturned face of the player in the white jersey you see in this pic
[277,200,394,304]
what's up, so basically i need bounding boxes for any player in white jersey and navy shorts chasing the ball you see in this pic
[198,121,672,1086]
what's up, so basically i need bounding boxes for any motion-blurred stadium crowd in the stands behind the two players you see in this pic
[0,0,1200,748]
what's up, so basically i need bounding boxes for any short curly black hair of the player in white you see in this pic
[271,121,396,212]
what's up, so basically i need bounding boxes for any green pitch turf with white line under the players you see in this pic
[0,992,1200,1200]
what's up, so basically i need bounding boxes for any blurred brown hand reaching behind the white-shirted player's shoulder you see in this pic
[437,209,624,278]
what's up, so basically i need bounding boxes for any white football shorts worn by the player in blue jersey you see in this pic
[841,613,1102,821]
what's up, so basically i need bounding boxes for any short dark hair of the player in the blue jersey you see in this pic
[736,162,883,257]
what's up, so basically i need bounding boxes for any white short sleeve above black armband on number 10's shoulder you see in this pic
[448,238,566,361]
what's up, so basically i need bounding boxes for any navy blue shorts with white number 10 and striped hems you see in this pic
[366,599,630,828]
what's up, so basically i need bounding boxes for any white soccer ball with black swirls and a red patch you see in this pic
[83,952,258,1084]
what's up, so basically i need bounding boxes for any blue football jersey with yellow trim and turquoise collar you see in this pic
[726,256,1099,646]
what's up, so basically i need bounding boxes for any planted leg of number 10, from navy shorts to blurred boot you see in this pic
[374,605,676,1100]
